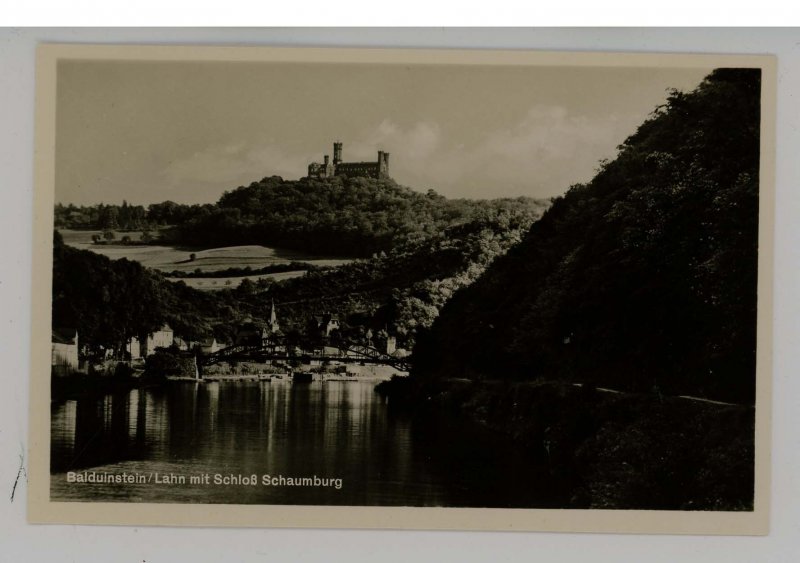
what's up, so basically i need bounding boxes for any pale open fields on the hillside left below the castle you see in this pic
[59,229,353,290]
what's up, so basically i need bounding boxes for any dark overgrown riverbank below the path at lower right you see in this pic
[377,379,755,510]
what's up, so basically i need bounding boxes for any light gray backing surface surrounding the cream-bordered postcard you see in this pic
[0,29,800,562]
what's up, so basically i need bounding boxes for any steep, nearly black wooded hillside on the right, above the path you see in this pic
[415,69,760,402]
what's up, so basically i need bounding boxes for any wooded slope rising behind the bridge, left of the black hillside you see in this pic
[254,210,532,349]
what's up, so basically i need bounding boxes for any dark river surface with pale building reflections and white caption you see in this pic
[51,381,555,507]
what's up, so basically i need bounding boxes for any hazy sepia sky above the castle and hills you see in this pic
[55,60,711,205]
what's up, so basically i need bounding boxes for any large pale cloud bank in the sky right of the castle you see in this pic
[344,105,630,197]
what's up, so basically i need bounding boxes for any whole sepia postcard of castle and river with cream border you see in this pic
[31,46,774,533]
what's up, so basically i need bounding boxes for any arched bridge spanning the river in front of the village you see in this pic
[197,338,411,372]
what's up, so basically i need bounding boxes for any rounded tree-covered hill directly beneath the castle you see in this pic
[164,176,547,257]
